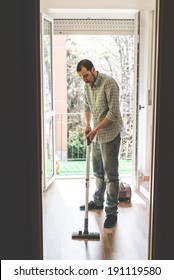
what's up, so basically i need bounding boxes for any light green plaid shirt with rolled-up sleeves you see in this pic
[84,73,123,143]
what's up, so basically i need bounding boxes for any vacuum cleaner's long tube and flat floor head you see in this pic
[72,138,100,240]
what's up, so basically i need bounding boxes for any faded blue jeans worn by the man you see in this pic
[92,134,121,215]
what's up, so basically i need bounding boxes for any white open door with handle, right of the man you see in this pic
[133,11,154,195]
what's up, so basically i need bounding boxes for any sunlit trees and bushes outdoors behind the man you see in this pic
[67,35,134,159]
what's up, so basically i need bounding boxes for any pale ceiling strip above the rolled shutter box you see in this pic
[40,0,157,19]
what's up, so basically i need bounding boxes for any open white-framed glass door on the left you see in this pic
[41,13,55,190]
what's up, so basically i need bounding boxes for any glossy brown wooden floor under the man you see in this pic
[43,178,149,260]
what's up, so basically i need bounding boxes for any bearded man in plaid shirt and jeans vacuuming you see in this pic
[76,59,123,228]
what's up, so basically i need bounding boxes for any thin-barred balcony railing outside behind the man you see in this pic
[55,113,132,161]
